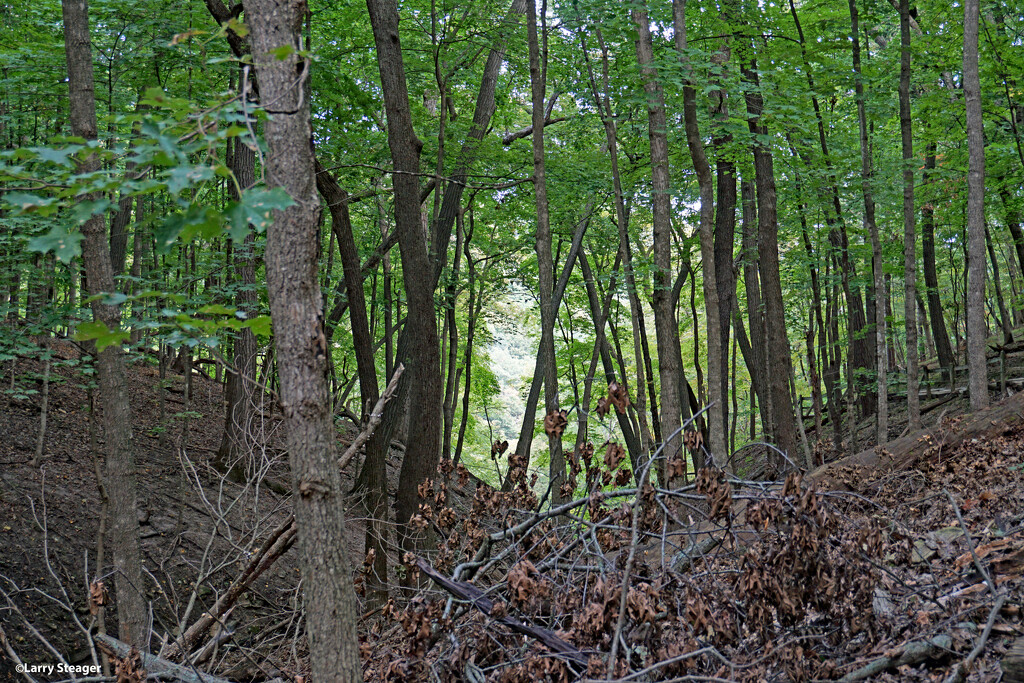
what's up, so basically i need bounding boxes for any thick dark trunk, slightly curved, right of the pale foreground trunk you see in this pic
[367,0,442,573]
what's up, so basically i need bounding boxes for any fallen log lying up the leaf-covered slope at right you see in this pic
[804,392,1024,489]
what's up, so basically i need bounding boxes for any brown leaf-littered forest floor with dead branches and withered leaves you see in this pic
[0,339,1024,681]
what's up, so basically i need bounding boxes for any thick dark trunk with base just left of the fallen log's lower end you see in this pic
[743,60,797,465]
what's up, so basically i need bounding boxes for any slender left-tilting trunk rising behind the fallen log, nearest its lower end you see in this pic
[850,0,889,445]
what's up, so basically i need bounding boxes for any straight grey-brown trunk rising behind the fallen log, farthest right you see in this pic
[964,0,988,411]
